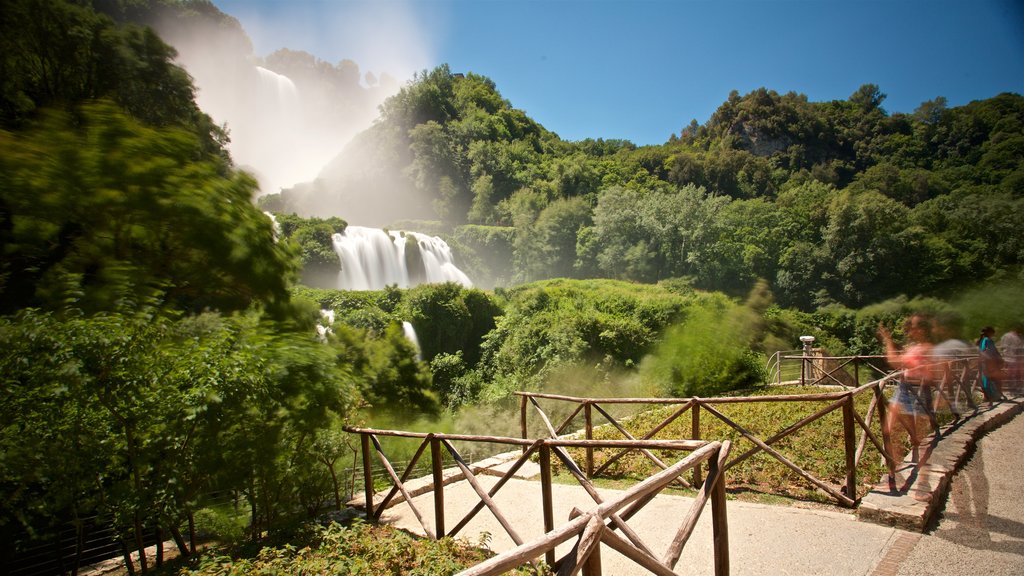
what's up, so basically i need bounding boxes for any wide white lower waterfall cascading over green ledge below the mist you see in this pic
[334,227,473,290]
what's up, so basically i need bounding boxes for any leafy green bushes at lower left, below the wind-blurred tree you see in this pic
[0,310,355,557]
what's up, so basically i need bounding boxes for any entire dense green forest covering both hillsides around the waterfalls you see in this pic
[0,0,1024,569]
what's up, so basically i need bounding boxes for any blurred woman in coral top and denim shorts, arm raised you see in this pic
[879,314,934,463]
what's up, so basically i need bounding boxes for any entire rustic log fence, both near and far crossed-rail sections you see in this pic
[345,358,978,576]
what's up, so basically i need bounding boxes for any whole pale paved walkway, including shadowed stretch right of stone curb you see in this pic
[376,401,1024,576]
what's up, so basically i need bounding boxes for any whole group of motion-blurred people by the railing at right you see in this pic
[879,313,1024,462]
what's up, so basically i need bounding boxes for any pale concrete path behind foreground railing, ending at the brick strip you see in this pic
[383,479,896,576]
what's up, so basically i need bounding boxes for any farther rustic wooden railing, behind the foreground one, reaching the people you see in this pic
[516,359,977,507]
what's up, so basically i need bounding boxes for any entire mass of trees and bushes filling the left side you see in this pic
[0,0,359,573]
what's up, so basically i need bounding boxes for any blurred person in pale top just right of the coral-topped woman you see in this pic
[932,311,977,417]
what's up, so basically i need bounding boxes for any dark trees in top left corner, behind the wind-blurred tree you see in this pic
[0,0,227,154]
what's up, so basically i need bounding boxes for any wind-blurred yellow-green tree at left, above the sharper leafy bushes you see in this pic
[0,101,297,312]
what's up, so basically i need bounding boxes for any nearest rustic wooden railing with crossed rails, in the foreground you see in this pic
[345,426,730,576]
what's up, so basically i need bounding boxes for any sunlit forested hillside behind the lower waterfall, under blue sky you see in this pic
[264,66,1024,310]
